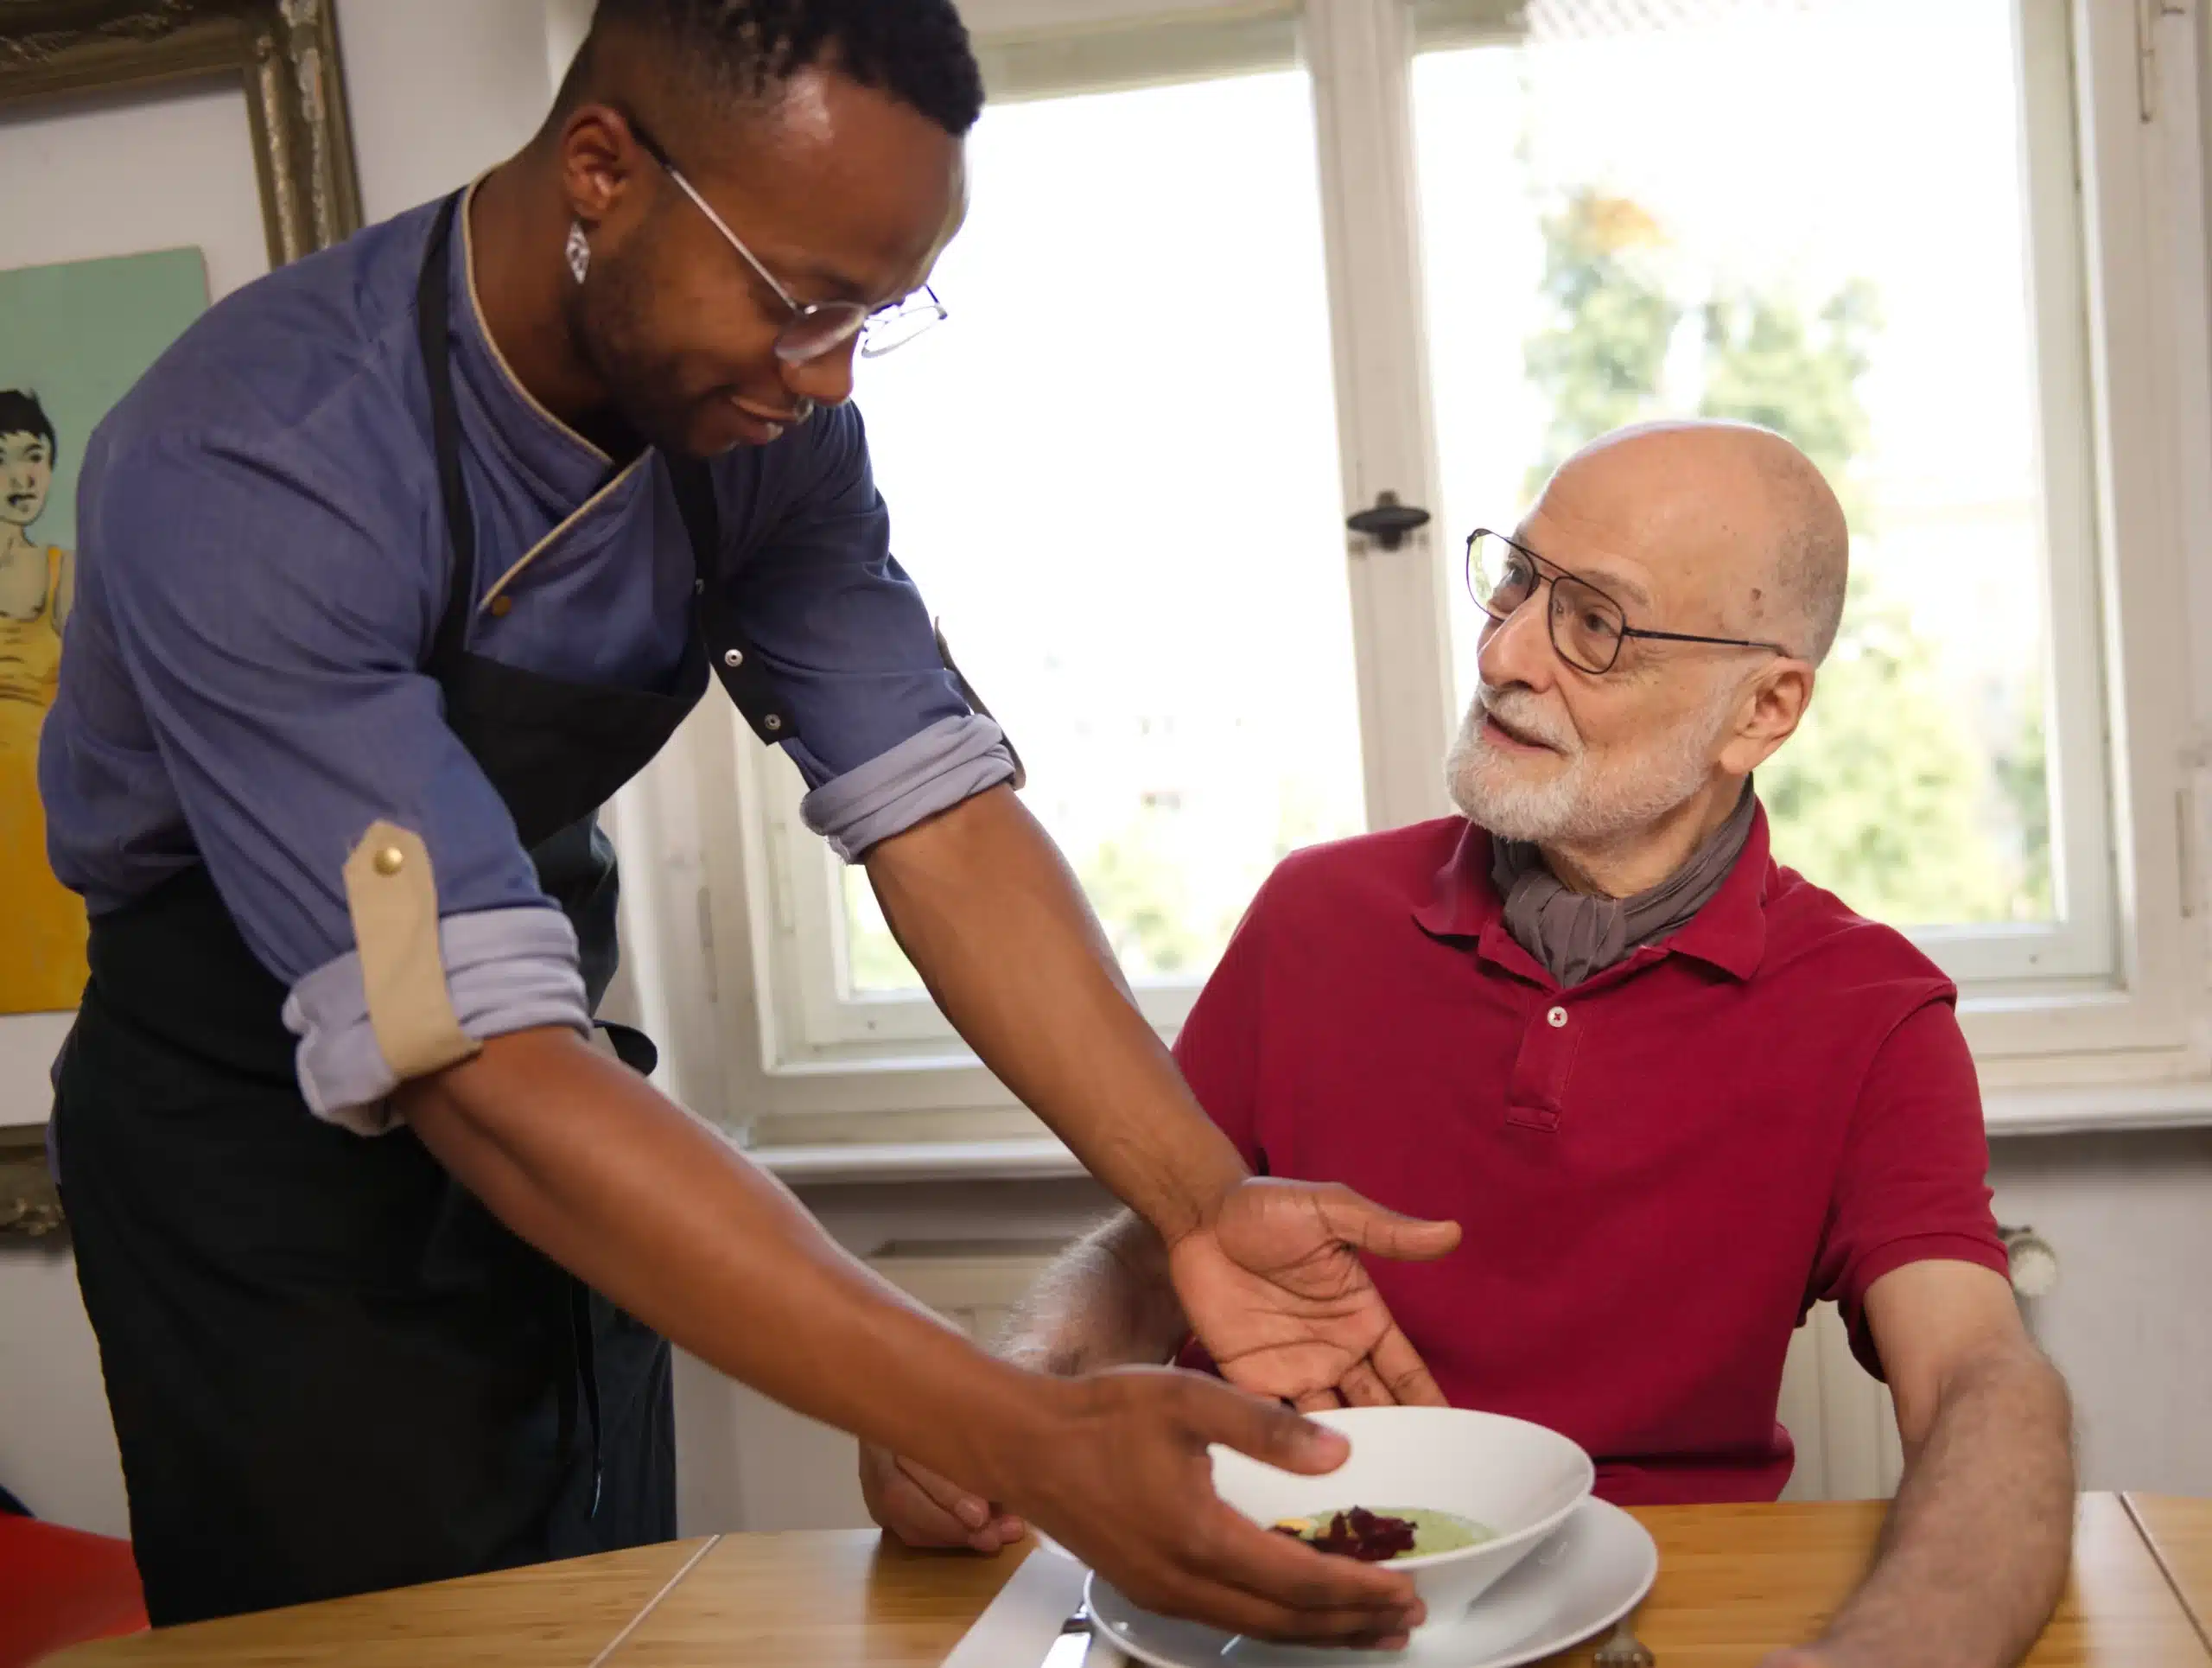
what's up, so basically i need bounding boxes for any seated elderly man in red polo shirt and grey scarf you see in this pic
[862,423,2073,1668]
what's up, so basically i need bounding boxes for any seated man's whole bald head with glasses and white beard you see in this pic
[1445,423,1822,875]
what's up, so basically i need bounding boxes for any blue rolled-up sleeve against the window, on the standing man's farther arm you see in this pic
[736,404,1015,863]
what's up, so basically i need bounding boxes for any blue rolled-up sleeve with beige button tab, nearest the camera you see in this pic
[79,436,588,1133]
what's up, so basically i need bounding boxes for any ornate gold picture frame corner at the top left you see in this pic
[0,0,360,265]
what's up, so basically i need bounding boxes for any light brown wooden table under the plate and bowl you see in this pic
[58,1495,2212,1668]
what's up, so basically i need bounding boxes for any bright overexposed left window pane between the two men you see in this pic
[841,67,1365,1017]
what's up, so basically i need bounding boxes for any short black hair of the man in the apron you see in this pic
[560,0,982,139]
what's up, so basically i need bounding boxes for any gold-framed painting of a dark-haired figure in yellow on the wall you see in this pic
[0,0,360,1237]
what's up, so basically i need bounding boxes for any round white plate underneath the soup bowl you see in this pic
[1089,1499,1659,1668]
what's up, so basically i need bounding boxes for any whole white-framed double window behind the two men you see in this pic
[657,0,2212,1142]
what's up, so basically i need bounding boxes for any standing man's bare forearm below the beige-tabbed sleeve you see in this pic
[400,1031,1061,1487]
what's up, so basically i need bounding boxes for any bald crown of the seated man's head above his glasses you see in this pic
[1537,420,1852,665]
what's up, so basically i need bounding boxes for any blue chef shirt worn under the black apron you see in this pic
[40,191,1013,1130]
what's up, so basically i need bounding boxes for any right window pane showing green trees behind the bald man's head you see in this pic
[1411,0,2113,984]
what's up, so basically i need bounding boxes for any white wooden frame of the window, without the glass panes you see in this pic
[611,0,2212,1148]
